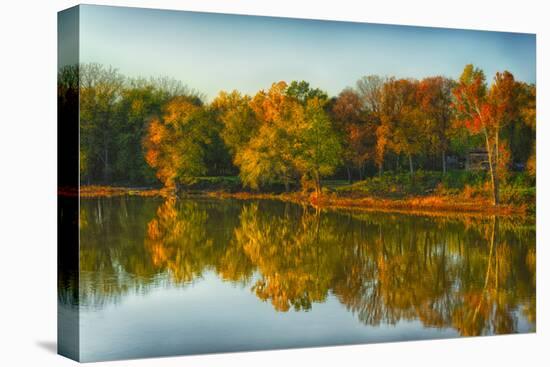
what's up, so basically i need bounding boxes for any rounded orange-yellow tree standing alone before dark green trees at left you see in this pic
[143,96,212,187]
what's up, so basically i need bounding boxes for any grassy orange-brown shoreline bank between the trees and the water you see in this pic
[75,172,535,216]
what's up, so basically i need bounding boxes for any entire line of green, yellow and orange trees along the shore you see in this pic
[59,64,536,204]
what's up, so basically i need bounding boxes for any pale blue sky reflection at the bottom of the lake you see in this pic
[80,272,458,361]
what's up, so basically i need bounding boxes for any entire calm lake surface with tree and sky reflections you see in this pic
[64,197,536,361]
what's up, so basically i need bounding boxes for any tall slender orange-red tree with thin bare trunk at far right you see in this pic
[453,64,518,205]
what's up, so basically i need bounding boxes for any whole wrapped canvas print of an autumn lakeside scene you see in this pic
[57,5,536,361]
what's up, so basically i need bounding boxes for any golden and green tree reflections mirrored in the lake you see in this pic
[70,198,536,335]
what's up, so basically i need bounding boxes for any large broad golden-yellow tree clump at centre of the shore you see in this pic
[232,81,340,193]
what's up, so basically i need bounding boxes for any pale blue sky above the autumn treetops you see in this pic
[72,5,536,100]
